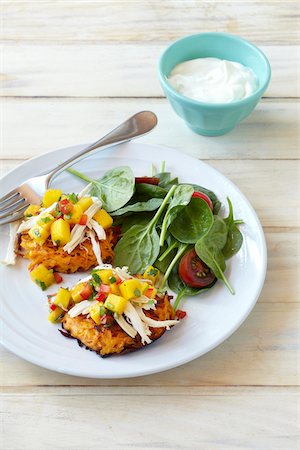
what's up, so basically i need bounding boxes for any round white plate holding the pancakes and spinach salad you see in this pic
[0,143,267,378]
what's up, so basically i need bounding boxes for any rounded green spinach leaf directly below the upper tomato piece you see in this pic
[169,198,214,244]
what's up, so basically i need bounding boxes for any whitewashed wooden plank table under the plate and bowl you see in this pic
[0,0,300,450]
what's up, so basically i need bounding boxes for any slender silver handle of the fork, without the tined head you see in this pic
[46,111,157,188]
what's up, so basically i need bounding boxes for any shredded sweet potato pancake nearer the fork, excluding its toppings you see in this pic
[20,228,116,273]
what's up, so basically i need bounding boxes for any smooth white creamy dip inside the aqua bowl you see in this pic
[168,58,258,103]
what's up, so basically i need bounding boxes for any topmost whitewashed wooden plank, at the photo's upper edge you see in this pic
[0,0,299,45]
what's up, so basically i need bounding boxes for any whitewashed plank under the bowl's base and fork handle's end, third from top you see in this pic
[0,98,300,162]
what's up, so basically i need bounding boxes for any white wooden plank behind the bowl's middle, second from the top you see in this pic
[0,41,300,97]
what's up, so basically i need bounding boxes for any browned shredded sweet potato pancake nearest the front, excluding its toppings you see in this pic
[62,294,175,356]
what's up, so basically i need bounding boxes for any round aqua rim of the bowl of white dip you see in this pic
[157,31,271,109]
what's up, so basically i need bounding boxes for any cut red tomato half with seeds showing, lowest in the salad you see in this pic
[178,249,216,289]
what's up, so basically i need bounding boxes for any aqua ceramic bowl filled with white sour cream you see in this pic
[158,33,271,136]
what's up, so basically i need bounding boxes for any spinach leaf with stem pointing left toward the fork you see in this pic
[67,166,134,212]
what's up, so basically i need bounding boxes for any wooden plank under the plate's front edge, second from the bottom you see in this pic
[0,303,300,392]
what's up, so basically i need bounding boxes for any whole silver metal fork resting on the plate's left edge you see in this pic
[0,111,157,225]
